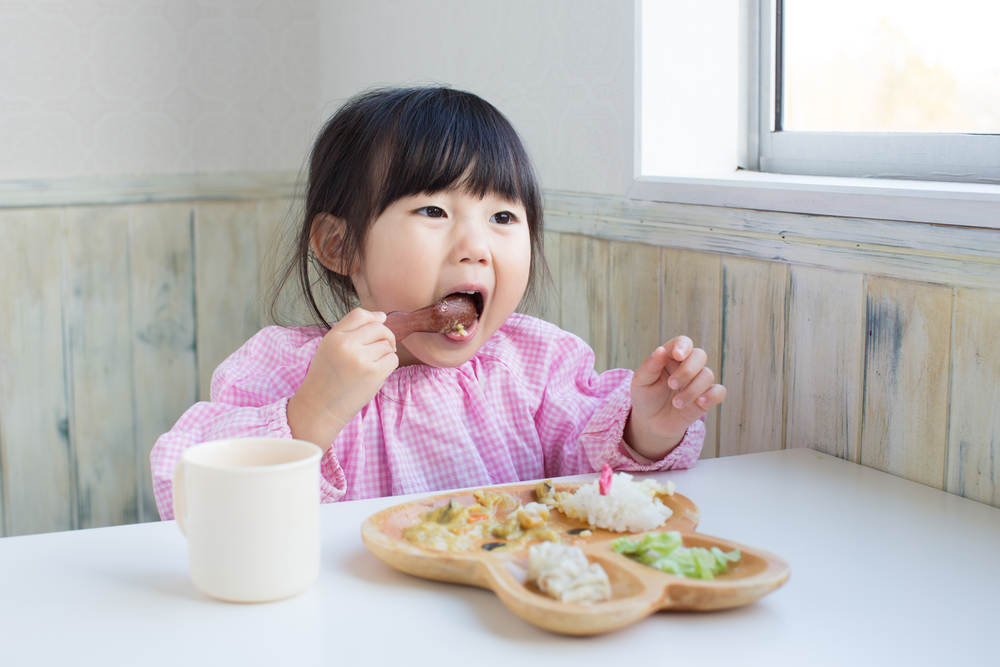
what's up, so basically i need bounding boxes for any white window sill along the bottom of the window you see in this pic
[627,171,1000,229]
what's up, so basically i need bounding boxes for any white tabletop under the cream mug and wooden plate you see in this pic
[0,449,1000,667]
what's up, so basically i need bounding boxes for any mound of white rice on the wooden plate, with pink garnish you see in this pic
[556,472,674,533]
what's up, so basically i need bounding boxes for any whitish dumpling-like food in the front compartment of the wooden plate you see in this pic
[528,542,611,604]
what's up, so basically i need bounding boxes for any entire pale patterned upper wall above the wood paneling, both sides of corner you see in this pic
[0,0,634,194]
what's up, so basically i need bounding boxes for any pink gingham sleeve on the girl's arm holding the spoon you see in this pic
[150,327,346,520]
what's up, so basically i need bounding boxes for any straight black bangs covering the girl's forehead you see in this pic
[372,89,539,217]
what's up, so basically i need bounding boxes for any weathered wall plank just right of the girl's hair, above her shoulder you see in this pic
[559,234,611,373]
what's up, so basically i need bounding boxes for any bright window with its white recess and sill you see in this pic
[627,0,1000,229]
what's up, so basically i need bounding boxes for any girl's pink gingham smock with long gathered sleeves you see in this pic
[150,314,705,519]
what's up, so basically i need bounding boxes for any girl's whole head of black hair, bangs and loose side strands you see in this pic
[272,87,548,327]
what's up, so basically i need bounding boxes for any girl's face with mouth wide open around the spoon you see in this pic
[351,190,531,367]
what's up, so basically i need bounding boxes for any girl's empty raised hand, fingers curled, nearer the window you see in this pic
[625,336,726,460]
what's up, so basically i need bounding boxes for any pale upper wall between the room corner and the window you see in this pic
[321,0,635,195]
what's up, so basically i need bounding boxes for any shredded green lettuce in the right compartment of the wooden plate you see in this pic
[611,530,740,580]
